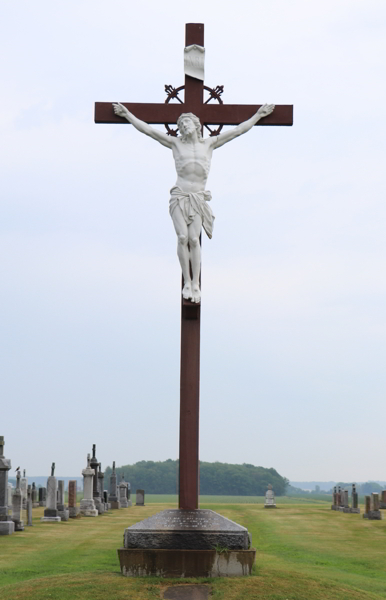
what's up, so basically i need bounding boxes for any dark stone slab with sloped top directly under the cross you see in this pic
[124,509,249,550]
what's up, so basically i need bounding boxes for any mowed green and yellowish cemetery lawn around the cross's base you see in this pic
[0,497,386,600]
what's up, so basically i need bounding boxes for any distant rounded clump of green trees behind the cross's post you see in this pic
[105,459,288,496]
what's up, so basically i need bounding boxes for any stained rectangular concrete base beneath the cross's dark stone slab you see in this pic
[118,548,256,578]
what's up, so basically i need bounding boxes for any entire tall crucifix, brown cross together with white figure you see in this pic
[95,23,293,509]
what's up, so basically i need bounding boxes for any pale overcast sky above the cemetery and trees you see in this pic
[0,0,386,481]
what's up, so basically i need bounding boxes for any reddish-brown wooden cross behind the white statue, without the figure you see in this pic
[95,23,293,509]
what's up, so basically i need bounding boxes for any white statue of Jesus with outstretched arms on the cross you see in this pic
[113,103,275,303]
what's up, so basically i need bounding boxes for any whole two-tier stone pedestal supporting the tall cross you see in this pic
[118,509,255,577]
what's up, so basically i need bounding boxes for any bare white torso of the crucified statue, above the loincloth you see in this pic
[172,139,213,192]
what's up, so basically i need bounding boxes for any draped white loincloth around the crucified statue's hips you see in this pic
[169,185,214,239]
